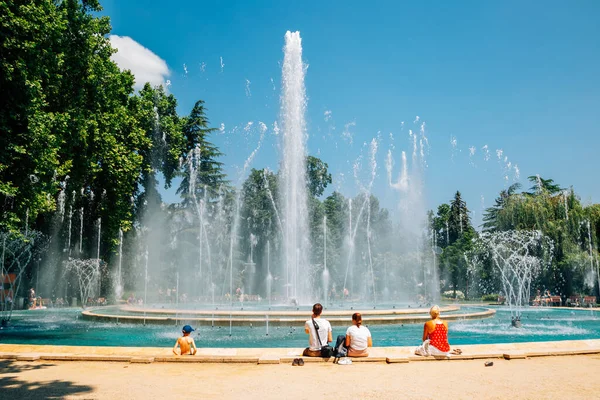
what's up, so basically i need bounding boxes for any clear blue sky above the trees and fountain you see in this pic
[102,0,600,225]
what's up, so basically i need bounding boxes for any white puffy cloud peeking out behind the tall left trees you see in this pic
[109,35,171,89]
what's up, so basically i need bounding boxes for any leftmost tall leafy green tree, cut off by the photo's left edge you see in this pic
[0,0,68,231]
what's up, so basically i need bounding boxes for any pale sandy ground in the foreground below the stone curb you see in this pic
[0,355,600,400]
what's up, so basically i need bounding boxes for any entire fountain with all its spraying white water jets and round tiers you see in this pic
[2,32,593,347]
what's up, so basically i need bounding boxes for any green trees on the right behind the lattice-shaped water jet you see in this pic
[430,176,600,298]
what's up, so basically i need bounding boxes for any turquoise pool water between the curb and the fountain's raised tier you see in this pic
[0,307,600,348]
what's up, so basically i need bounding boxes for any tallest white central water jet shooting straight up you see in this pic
[280,31,312,302]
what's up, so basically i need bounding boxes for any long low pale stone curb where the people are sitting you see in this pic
[0,339,600,365]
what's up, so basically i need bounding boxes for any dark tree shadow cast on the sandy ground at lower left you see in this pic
[0,360,93,400]
